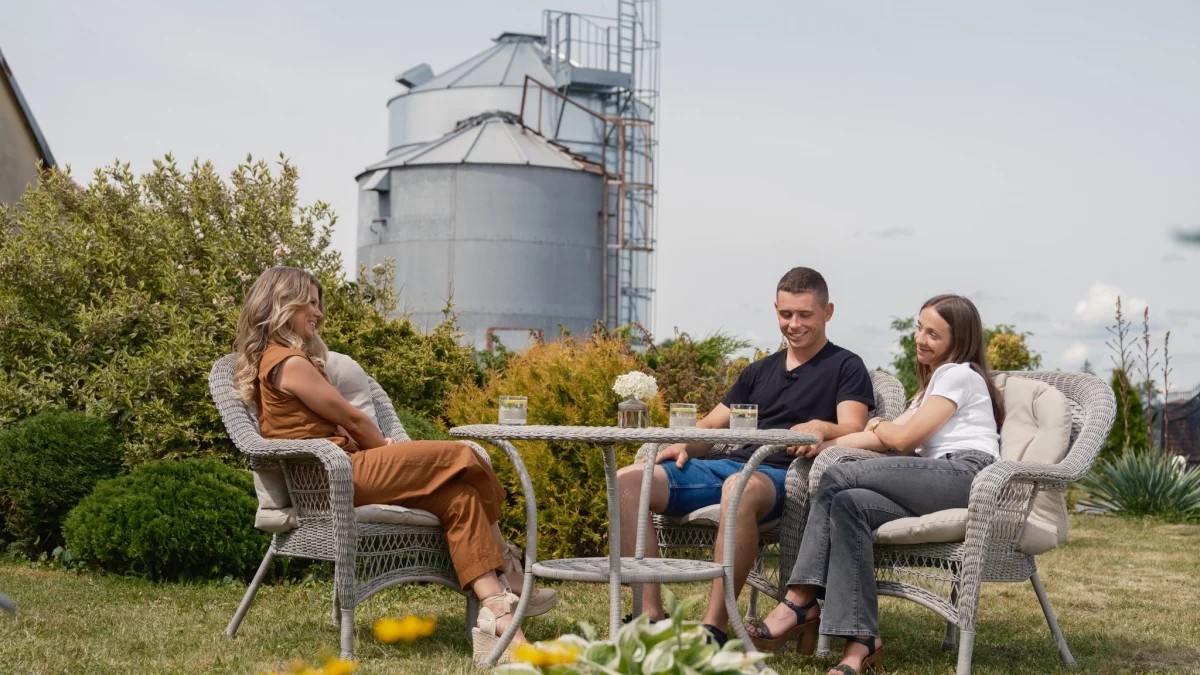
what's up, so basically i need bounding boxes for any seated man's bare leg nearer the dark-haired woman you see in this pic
[704,472,775,631]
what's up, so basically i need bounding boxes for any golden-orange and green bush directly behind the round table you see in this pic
[446,335,666,557]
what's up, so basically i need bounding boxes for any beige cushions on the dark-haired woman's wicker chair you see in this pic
[875,375,1070,555]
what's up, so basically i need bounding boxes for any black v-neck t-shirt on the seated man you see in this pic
[721,342,875,468]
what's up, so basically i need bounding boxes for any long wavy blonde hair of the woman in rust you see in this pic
[233,267,329,402]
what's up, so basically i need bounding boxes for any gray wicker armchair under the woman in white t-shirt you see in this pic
[800,372,1116,675]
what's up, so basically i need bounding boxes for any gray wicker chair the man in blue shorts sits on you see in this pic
[637,371,905,617]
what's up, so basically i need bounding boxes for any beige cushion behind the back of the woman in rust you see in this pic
[246,352,384,533]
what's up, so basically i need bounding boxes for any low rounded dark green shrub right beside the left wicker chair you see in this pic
[62,459,270,580]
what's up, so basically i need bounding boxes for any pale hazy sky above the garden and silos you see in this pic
[0,0,1200,389]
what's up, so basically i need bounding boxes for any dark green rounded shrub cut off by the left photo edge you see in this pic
[0,411,122,556]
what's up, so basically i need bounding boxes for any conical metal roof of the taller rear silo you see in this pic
[409,32,554,94]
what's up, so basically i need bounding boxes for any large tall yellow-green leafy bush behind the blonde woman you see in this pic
[0,156,475,466]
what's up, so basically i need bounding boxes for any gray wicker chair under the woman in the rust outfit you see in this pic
[209,354,499,657]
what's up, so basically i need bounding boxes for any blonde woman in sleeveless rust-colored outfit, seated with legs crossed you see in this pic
[234,268,557,661]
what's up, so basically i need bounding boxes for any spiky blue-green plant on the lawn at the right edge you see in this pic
[1079,450,1200,519]
